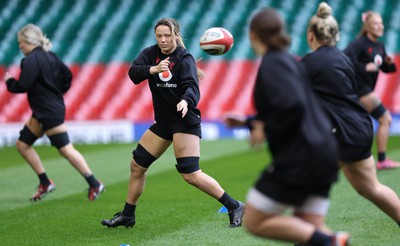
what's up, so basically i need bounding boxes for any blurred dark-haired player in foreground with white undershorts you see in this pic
[239,8,349,246]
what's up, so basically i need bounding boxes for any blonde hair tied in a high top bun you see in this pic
[308,2,339,46]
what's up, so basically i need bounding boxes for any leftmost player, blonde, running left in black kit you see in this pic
[5,24,104,201]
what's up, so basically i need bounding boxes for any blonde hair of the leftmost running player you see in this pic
[18,24,52,51]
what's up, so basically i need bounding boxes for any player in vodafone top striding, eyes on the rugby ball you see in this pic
[102,18,244,227]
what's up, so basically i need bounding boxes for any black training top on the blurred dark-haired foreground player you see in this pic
[254,51,338,187]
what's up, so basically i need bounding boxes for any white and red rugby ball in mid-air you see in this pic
[200,27,233,56]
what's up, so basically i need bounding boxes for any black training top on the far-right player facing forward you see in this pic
[344,35,396,96]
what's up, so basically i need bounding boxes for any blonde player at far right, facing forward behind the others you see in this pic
[344,11,400,169]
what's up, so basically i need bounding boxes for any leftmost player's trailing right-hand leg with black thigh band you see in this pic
[43,120,105,201]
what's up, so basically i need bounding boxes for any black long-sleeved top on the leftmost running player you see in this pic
[6,47,72,119]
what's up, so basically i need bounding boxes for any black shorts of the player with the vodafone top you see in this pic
[149,123,201,141]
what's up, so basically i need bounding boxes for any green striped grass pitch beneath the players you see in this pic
[0,137,400,246]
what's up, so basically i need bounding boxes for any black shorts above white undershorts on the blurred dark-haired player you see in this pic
[255,179,331,206]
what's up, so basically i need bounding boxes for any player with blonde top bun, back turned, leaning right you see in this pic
[303,3,400,229]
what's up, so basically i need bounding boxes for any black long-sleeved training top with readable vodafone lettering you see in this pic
[129,45,201,126]
